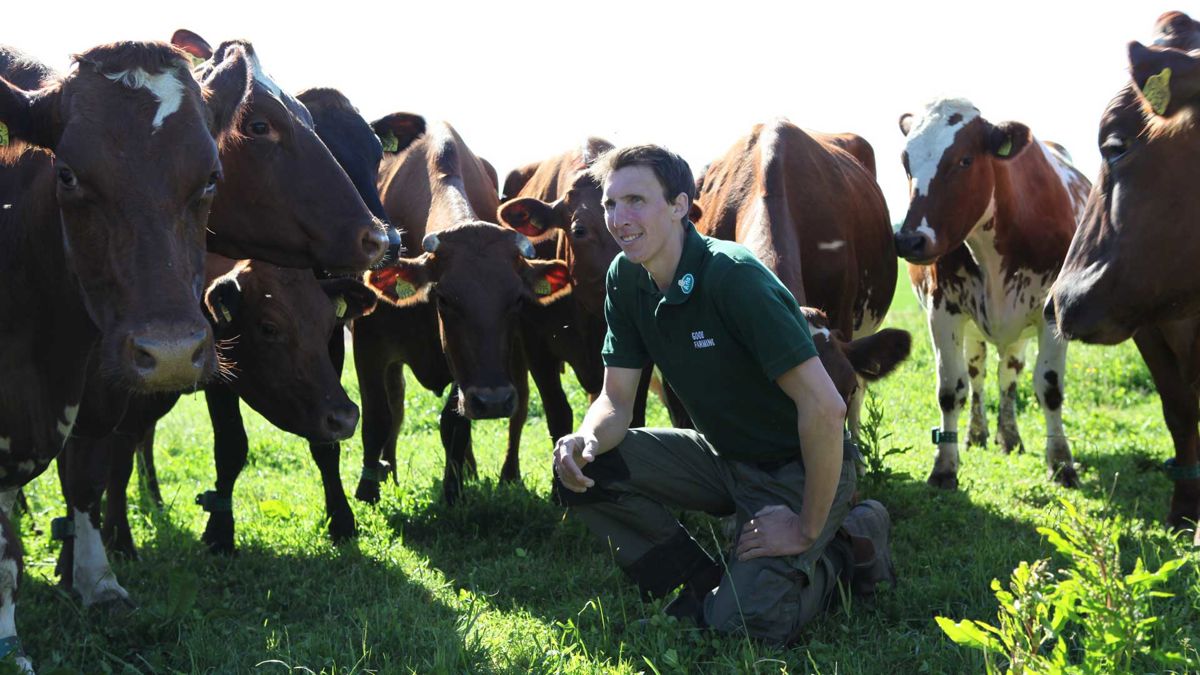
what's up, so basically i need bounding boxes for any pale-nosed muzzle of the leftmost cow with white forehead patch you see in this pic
[101,317,217,394]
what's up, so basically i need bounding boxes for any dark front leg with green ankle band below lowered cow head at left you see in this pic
[196,384,250,554]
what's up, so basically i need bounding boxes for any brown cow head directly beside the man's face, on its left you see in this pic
[497,145,620,316]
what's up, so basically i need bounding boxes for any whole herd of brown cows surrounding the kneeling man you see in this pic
[0,12,1200,671]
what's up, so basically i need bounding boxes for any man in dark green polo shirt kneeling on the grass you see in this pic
[554,145,894,644]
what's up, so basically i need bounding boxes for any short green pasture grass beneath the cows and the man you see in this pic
[9,265,1200,675]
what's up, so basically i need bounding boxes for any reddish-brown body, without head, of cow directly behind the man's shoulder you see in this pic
[696,120,896,434]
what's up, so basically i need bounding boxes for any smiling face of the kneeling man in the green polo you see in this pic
[604,166,688,265]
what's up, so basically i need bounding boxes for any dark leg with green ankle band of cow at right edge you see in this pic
[1133,325,1200,539]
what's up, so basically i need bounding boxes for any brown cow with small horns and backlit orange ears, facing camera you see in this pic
[354,118,570,501]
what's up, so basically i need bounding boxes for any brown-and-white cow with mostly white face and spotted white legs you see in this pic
[895,98,1091,489]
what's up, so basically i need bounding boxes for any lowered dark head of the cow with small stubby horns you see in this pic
[368,221,571,419]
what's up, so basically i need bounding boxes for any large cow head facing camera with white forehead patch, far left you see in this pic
[0,42,250,392]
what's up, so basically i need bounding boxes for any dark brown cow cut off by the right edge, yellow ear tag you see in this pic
[1046,12,1200,544]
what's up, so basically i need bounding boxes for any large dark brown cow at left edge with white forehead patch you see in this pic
[0,42,250,668]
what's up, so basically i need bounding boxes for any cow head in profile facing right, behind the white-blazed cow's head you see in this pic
[172,30,388,270]
